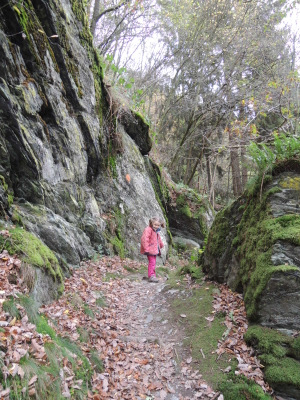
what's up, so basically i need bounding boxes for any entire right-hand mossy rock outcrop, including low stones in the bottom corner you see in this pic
[203,167,300,399]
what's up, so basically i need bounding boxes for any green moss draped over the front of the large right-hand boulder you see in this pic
[235,188,300,320]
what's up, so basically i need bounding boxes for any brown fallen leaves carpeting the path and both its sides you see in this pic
[0,251,271,400]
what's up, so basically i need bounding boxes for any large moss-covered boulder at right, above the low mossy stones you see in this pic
[204,167,300,329]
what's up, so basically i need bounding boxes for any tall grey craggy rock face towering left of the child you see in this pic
[0,0,168,300]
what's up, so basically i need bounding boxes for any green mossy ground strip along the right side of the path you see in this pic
[166,264,271,400]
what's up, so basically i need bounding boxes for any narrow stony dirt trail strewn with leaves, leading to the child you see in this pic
[110,275,222,400]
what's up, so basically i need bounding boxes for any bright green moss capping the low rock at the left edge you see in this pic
[0,227,63,283]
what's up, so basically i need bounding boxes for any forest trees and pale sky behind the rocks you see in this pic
[86,0,300,209]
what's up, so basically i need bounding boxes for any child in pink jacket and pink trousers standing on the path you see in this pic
[141,218,164,282]
